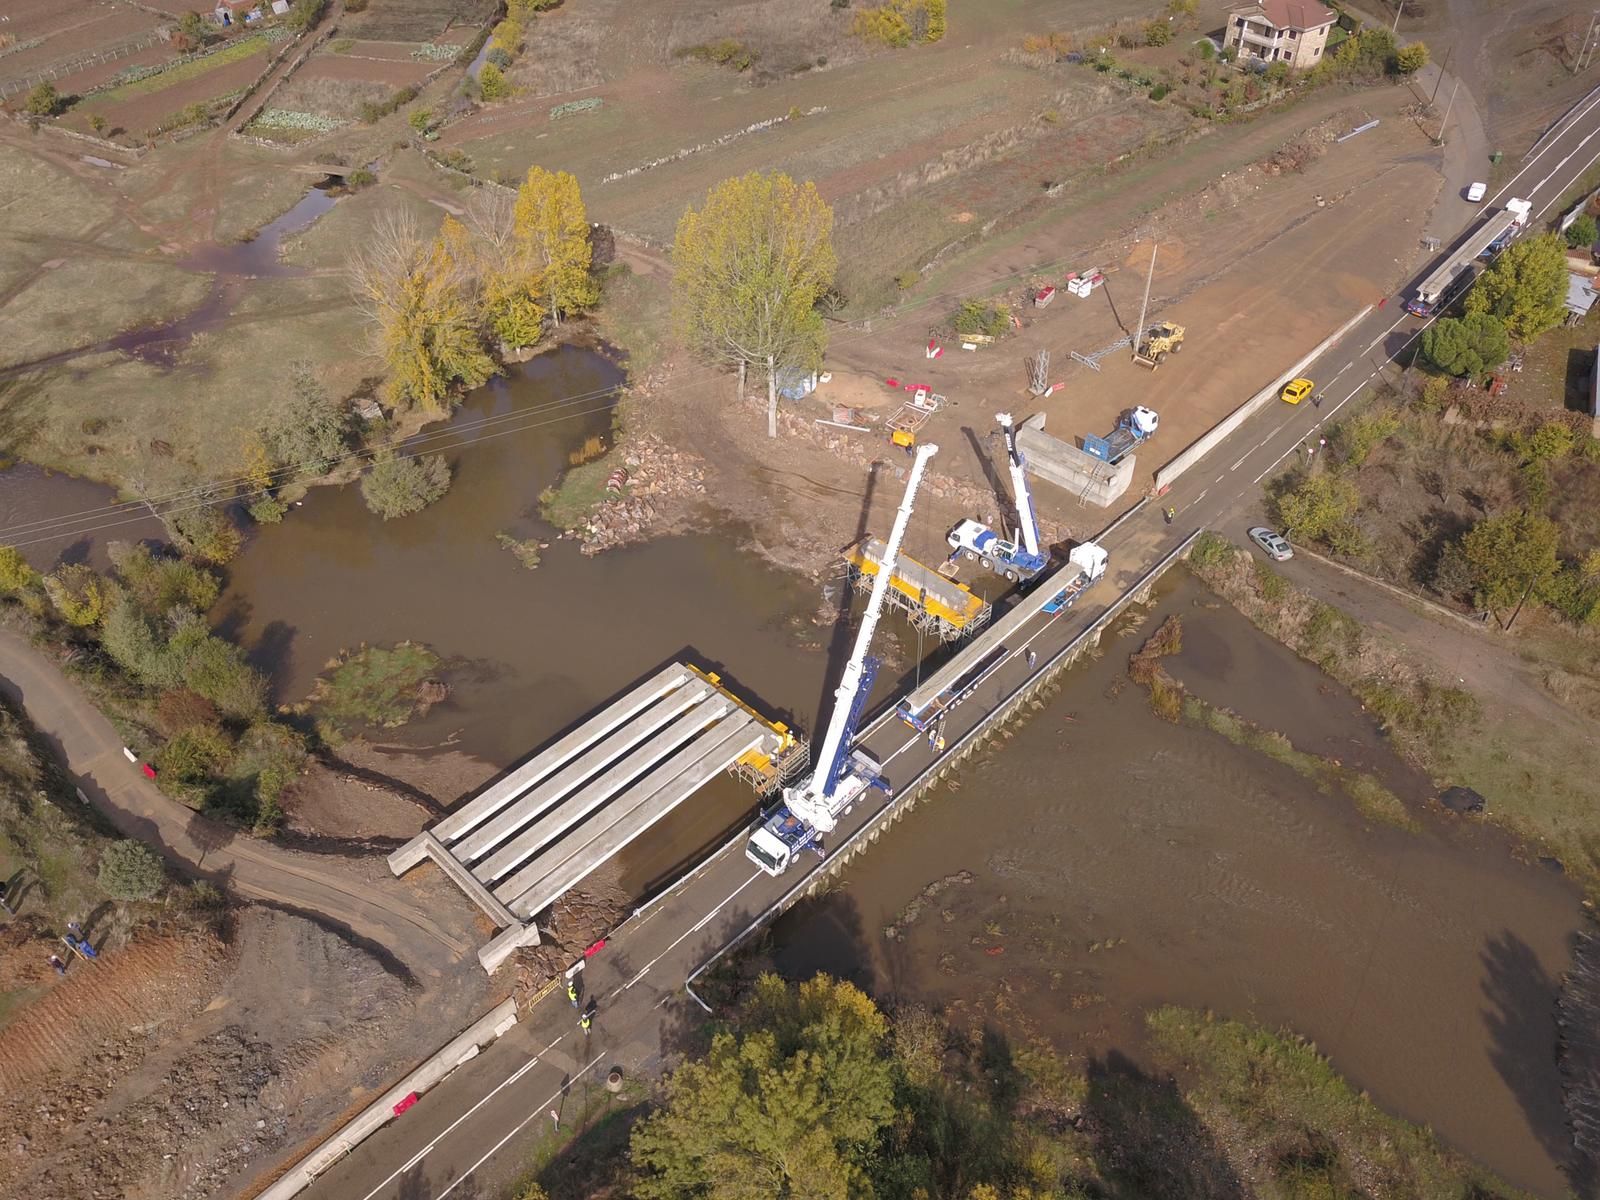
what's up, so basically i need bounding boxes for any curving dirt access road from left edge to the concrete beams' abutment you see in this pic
[0,632,475,986]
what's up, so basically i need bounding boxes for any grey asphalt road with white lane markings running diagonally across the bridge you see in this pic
[291,82,1600,1200]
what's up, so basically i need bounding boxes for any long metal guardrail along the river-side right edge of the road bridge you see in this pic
[683,531,1203,1013]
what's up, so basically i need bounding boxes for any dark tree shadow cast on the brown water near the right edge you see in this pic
[1478,930,1573,1196]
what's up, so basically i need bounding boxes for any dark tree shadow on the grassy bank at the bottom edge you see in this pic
[1083,1050,1248,1200]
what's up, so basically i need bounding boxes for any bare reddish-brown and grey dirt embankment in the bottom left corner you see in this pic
[0,907,482,1200]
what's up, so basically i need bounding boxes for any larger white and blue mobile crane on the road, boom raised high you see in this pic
[744,443,939,875]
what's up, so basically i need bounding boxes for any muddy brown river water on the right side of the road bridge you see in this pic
[774,582,1581,1195]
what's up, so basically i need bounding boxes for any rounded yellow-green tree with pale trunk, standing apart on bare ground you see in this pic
[672,171,838,437]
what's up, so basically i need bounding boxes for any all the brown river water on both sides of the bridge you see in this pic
[0,347,1581,1195]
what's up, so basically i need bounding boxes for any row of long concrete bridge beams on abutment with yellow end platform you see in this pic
[389,662,808,970]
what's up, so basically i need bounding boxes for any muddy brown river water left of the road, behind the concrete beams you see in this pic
[219,347,851,890]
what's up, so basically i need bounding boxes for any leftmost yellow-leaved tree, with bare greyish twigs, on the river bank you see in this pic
[350,213,494,416]
